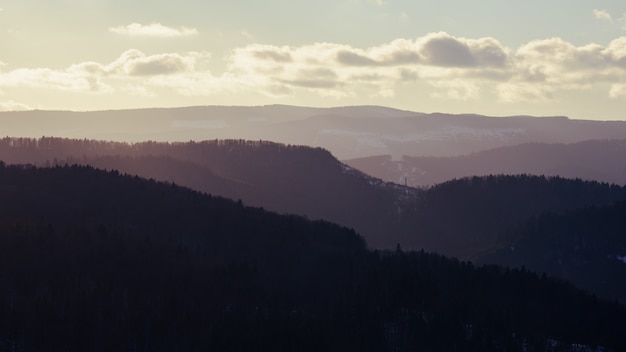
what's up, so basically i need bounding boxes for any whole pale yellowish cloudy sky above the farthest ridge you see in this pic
[0,0,626,120]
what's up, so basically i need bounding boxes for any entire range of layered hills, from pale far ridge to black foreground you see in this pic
[0,106,626,351]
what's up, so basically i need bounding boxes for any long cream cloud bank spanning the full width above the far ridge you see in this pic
[0,32,626,103]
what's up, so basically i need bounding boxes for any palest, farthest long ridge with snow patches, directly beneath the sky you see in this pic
[0,105,626,160]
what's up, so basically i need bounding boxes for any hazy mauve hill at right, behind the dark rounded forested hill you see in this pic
[344,139,626,187]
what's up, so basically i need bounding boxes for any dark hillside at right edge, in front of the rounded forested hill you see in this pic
[481,202,626,302]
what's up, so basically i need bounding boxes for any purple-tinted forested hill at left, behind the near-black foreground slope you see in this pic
[0,138,418,248]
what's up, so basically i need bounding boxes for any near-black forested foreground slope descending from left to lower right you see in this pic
[0,163,626,352]
